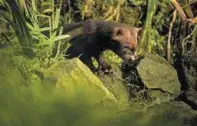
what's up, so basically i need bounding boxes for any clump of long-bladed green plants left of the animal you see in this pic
[0,0,69,67]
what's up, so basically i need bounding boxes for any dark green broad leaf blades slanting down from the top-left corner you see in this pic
[0,0,32,57]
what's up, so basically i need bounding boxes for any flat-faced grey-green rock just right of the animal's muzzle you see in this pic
[137,54,181,94]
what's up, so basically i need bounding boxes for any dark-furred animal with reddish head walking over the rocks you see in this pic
[64,20,140,71]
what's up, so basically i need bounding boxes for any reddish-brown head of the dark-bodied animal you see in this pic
[112,27,142,60]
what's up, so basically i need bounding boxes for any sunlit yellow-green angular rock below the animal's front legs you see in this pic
[43,58,116,103]
